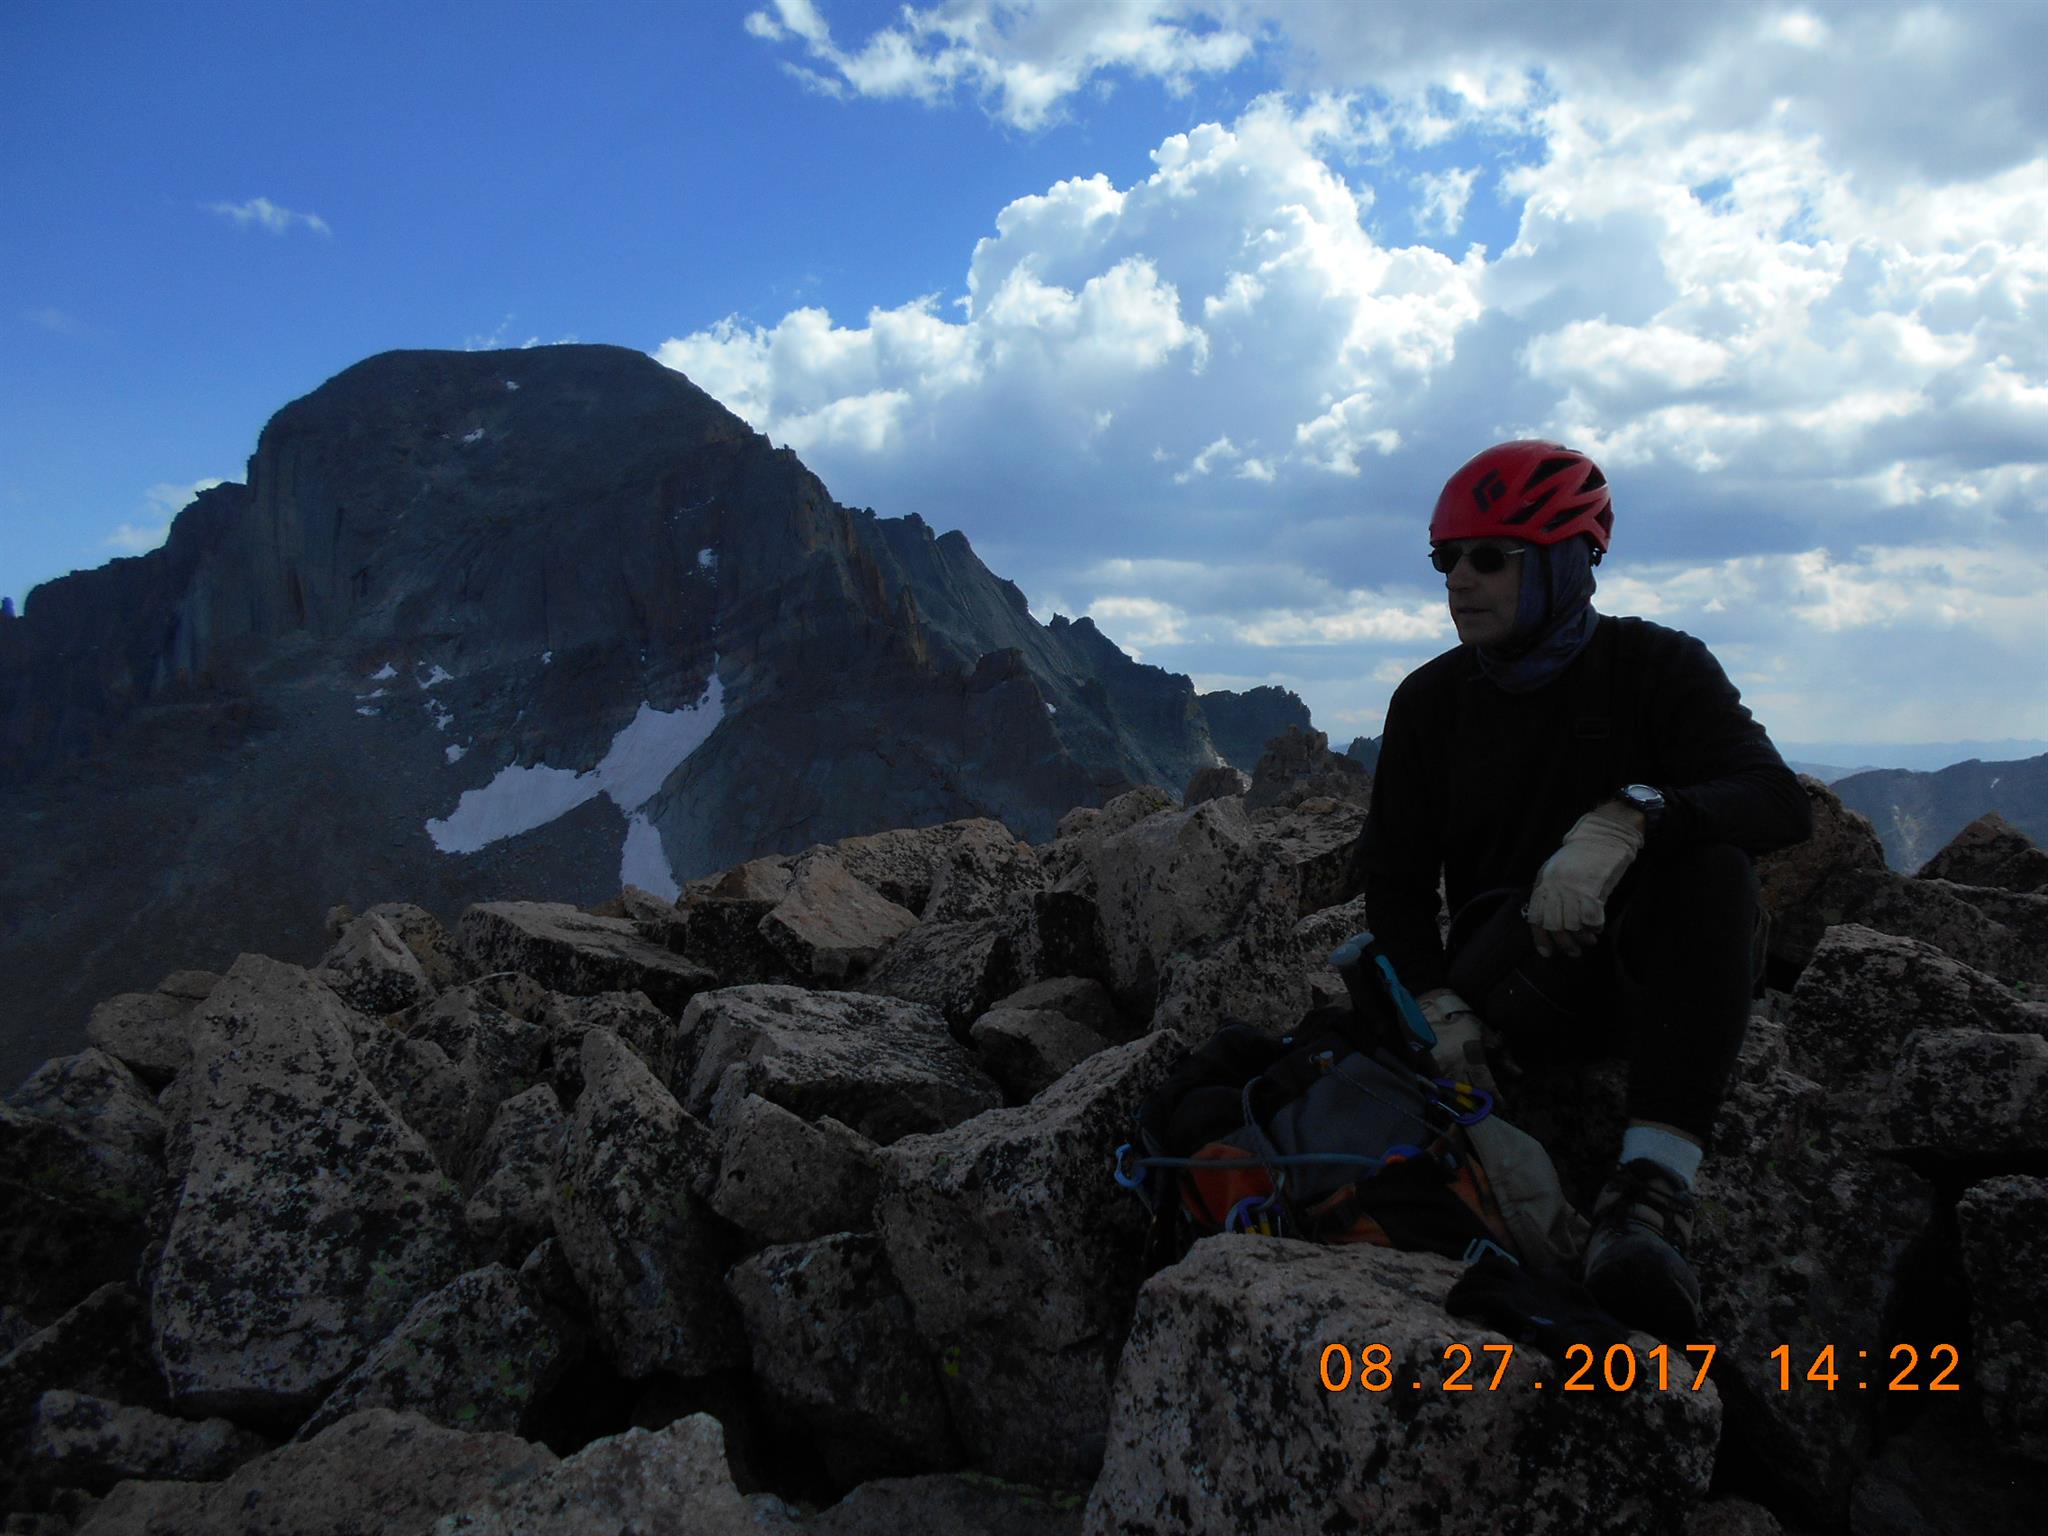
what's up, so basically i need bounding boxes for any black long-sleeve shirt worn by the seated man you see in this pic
[1352,616,1812,993]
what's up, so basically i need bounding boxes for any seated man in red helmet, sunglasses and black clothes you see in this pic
[1354,442,1812,1339]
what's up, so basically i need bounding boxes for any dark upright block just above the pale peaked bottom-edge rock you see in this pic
[725,1231,958,1485]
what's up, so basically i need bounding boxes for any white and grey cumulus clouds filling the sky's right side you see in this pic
[692,0,2048,737]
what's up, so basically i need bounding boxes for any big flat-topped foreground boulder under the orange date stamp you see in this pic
[1083,1237,1720,1536]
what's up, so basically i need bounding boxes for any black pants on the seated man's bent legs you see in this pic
[1448,844,1763,1145]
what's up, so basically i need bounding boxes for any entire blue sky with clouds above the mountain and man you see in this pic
[0,0,2048,757]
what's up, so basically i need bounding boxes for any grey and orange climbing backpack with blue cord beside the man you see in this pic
[1116,934,1585,1270]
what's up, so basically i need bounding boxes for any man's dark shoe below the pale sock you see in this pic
[1585,1157,1700,1343]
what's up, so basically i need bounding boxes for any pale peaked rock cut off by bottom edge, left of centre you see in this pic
[432,1413,799,1536]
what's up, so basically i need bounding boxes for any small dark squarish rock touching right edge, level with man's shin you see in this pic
[1890,1030,2048,1161]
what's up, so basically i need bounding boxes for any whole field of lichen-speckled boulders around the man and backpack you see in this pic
[0,782,2048,1536]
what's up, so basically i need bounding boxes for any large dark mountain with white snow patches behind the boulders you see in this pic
[0,346,1309,1081]
